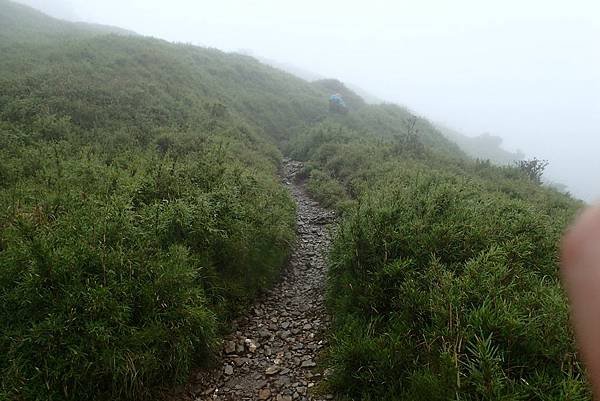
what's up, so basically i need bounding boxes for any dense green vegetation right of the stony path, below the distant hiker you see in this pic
[290,115,590,400]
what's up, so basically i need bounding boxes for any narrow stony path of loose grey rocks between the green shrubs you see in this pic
[173,160,333,401]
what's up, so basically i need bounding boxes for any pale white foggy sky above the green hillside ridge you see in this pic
[20,0,600,200]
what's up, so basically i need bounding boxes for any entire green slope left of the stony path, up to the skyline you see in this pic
[0,1,326,400]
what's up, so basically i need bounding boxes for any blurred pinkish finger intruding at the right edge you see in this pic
[561,207,600,398]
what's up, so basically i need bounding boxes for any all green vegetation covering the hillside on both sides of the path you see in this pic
[0,0,589,400]
